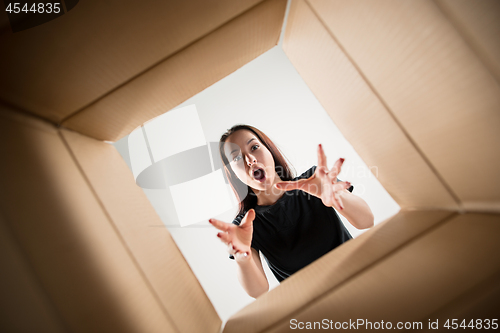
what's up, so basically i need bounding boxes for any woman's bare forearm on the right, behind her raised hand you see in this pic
[338,190,374,229]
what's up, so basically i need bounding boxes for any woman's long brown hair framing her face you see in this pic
[219,124,294,215]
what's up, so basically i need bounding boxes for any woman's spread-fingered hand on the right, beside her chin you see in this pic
[275,145,351,210]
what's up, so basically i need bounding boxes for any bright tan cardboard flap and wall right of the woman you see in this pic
[284,0,500,211]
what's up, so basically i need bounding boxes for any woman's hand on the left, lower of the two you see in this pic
[208,209,255,262]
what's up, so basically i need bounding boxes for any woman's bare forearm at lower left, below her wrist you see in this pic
[237,254,269,298]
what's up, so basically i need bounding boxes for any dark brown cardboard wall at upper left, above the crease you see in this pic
[0,0,259,123]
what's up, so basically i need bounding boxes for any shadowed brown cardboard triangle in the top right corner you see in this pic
[435,0,500,82]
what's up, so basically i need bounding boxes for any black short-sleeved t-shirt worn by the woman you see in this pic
[230,166,353,282]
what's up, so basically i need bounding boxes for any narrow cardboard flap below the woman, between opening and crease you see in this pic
[224,211,454,332]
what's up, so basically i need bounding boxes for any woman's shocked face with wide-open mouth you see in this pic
[224,129,280,190]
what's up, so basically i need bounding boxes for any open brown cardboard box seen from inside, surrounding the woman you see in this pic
[0,0,500,332]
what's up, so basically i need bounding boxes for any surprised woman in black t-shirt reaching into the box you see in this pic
[209,125,373,298]
